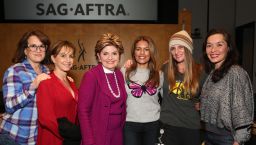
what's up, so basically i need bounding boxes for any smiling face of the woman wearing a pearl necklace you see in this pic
[97,45,120,70]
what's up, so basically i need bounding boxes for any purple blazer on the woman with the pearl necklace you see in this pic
[78,64,127,145]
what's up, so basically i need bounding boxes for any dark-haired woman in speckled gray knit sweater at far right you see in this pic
[201,29,254,145]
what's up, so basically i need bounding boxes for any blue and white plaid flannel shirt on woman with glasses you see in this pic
[0,60,49,145]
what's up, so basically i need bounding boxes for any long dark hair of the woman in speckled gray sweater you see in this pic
[203,29,238,83]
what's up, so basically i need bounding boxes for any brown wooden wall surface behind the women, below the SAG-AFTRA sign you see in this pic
[0,11,191,86]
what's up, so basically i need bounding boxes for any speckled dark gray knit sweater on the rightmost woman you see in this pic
[201,65,254,144]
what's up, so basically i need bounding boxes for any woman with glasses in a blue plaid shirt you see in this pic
[0,30,50,145]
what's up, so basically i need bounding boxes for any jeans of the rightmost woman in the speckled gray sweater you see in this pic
[205,131,234,145]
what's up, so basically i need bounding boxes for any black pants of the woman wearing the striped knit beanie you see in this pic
[162,125,201,145]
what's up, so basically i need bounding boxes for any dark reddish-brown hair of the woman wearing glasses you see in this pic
[12,30,51,64]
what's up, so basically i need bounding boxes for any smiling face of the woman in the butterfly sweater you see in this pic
[134,40,150,67]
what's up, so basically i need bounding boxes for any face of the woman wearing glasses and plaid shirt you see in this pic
[24,36,45,64]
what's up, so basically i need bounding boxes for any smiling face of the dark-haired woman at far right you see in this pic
[206,34,229,69]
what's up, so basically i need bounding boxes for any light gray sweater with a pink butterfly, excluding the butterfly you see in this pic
[121,68,163,123]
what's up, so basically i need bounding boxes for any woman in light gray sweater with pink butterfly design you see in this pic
[122,36,163,145]
